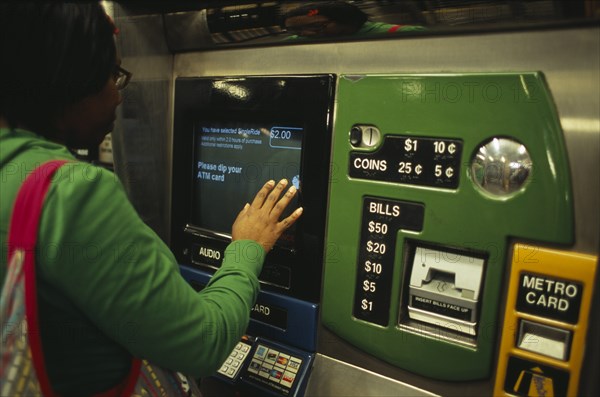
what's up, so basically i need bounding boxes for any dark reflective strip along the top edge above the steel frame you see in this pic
[122,0,600,52]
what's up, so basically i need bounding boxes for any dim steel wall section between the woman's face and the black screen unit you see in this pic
[111,7,173,241]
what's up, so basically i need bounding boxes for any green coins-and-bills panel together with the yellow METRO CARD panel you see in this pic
[322,73,597,395]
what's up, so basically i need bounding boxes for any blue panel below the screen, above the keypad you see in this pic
[180,265,319,352]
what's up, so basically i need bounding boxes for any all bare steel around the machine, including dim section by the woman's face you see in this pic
[113,16,600,396]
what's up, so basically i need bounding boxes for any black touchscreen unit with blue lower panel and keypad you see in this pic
[172,75,335,396]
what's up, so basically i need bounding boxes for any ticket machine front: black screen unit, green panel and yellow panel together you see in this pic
[172,73,597,395]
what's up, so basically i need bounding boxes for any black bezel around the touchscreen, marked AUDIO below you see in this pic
[171,75,335,302]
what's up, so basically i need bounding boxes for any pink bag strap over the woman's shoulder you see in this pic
[8,160,66,396]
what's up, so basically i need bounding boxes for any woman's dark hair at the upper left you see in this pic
[0,1,116,135]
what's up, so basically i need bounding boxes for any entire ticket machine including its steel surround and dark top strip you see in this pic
[113,0,600,397]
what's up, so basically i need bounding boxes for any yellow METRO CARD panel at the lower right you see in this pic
[494,244,598,396]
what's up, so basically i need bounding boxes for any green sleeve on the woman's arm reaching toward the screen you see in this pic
[38,164,265,377]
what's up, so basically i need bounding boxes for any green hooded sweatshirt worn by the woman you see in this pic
[0,128,265,395]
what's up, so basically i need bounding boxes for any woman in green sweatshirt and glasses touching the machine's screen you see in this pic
[0,2,302,395]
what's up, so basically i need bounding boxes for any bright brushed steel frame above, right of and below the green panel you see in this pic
[174,27,600,396]
